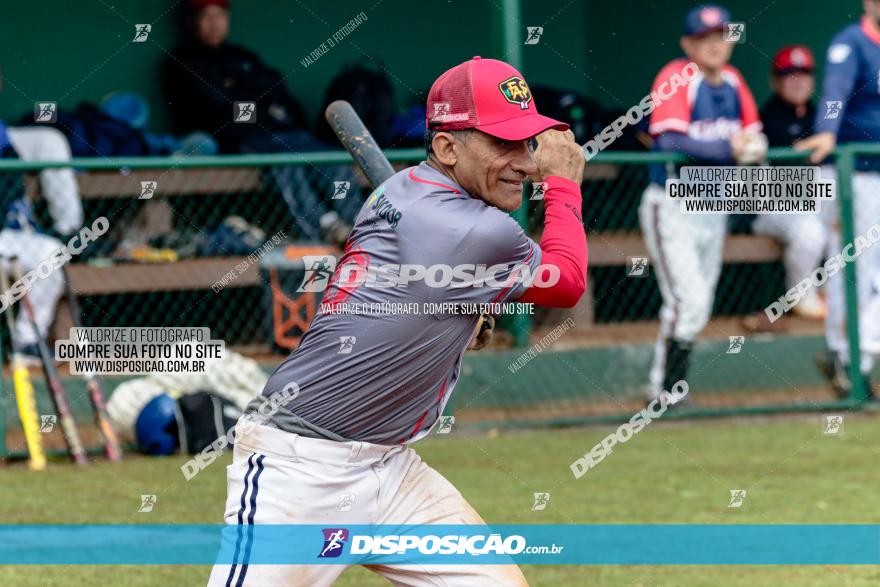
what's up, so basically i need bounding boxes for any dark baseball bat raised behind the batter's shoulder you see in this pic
[324,100,394,189]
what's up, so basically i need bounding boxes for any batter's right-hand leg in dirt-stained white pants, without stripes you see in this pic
[365,448,528,587]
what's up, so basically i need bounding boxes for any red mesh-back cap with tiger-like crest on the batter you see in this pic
[425,57,568,141]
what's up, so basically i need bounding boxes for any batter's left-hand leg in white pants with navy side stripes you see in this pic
[208,426,379,587]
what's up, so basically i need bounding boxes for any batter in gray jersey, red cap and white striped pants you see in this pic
[209,57,587,587]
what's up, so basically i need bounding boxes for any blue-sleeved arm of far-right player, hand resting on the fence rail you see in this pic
[794,35,858,163]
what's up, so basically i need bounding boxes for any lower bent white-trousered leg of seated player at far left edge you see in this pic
[0,229,64,345]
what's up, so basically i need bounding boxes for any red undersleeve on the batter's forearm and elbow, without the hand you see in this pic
[517,176,588,308]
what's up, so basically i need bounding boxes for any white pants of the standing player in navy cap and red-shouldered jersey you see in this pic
[639,183,727,397]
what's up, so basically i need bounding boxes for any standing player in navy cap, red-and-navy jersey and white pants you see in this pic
[639,5,761,399]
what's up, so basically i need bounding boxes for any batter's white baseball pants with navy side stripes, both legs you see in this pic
[208,425,527,587]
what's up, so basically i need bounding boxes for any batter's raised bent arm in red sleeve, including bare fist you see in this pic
[517,131,588,308]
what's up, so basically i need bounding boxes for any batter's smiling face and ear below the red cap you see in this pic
[438,131,538,211]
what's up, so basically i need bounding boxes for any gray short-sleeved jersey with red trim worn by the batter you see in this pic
[254,163,544,445]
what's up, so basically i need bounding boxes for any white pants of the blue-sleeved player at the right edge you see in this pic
[822,166,880,372]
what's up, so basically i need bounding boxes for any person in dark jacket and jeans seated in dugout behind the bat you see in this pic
[162,0,361,243]
